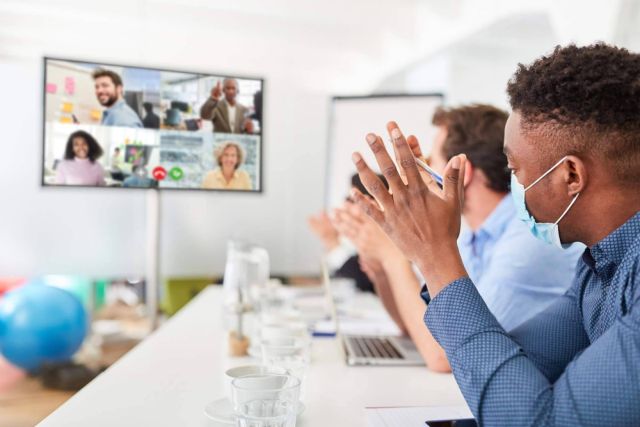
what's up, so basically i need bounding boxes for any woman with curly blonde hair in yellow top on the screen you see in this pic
[202,141,252,190]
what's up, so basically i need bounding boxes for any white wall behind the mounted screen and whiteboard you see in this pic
[0,0,639,276]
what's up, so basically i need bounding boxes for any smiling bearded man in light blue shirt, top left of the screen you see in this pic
[93,68,142,128]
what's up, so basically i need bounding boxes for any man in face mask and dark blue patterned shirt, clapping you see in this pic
[353,44,640,426]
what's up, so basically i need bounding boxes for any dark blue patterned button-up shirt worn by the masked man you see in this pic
[423,212,640,426]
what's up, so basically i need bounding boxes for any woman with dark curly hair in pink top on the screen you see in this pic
[55,130,106,186]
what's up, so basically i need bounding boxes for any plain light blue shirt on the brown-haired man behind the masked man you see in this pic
[458,194,584,330]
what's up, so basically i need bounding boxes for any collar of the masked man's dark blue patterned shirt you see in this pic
[583,212,640,274]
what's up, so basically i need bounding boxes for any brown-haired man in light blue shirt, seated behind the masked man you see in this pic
[336,105,582,371]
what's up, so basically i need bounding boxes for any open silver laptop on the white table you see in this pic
[322,260,425,366]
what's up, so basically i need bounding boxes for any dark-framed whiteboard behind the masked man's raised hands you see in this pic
[325,94,443,209]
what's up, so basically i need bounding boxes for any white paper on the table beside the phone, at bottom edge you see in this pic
[365,405,473,427]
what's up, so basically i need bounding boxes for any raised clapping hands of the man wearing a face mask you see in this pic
[352,122,466,297]
